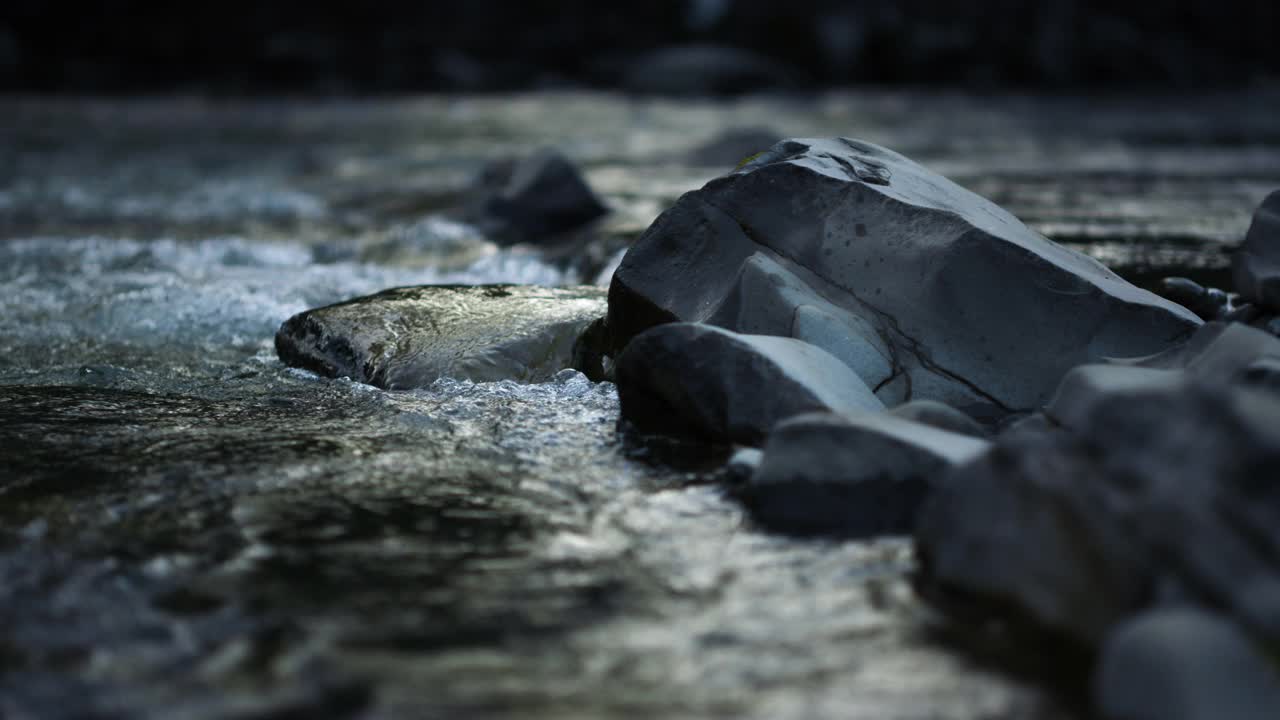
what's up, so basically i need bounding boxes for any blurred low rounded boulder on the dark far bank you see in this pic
[622,45,797,96]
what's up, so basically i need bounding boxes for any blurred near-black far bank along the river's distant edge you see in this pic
[0,0,1280,94]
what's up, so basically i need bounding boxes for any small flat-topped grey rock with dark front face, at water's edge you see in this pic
[742,413,988,538]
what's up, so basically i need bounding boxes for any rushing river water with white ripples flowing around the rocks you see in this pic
[0,94,1280,719]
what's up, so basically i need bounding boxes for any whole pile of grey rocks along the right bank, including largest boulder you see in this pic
[603,140,1280,719]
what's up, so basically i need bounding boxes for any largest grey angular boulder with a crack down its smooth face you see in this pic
[608,138,1201,420]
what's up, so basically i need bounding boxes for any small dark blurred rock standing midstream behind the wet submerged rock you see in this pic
[465,149,608,245]
